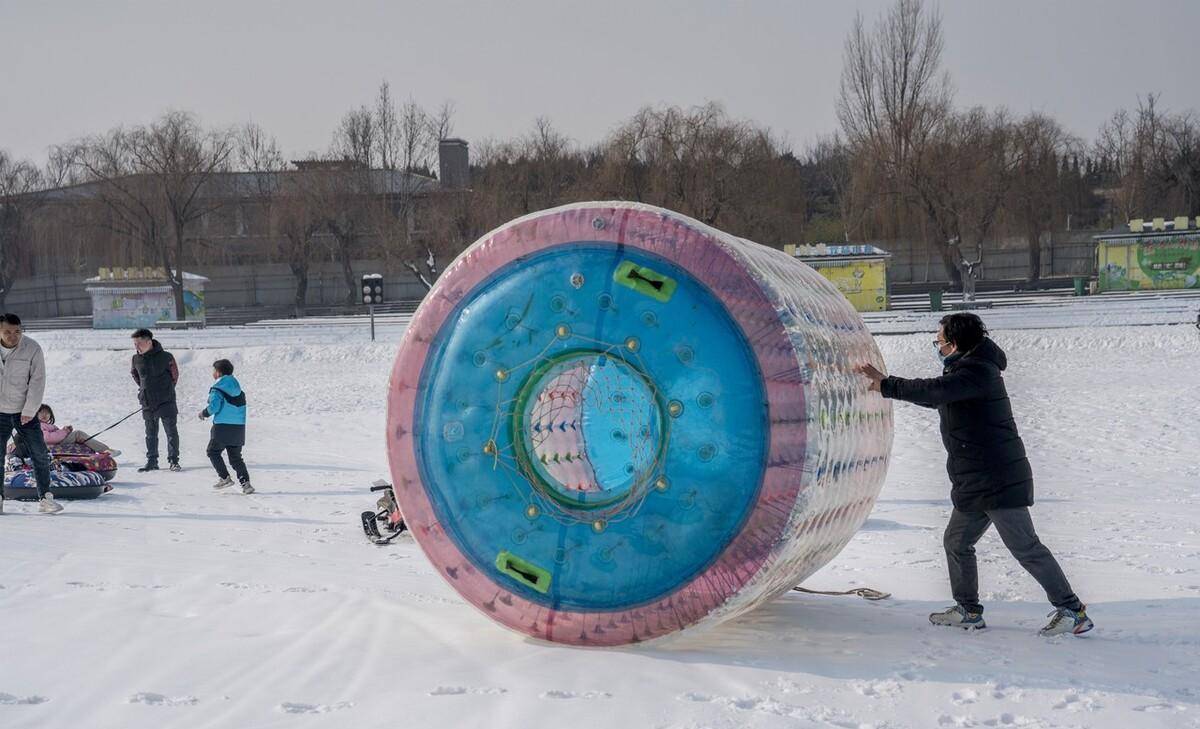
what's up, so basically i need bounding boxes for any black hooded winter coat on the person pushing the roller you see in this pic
[880,338,1033,512]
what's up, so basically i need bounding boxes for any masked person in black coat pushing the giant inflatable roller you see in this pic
[859,313,1093,635]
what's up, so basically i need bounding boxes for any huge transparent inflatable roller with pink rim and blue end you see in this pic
[386,203,892,646]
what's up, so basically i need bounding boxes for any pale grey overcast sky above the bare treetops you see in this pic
[0,0,1200,162]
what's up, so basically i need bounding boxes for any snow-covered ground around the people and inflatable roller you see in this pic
[0,300,1200,729]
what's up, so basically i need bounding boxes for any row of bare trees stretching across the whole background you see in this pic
[0,12,1200,315]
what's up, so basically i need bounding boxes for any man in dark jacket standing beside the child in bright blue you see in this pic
[130,329,181,472]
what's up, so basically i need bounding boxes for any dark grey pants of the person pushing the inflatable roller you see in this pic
[943,507,1084,613]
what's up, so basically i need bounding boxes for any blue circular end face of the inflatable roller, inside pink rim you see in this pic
[415,242,767,610]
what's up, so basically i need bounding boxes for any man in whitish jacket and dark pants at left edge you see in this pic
[0,314,62,514]
